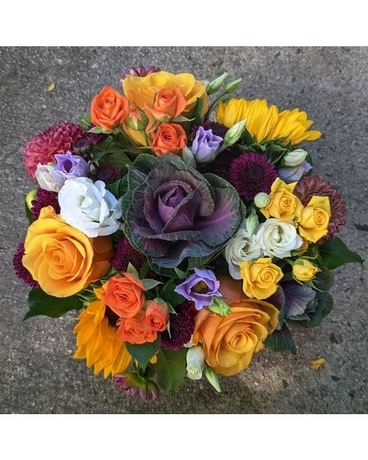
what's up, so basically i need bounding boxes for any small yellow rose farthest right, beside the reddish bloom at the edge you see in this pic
[297,196,331,243]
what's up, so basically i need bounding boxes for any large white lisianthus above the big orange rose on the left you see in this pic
[58,177,121,238]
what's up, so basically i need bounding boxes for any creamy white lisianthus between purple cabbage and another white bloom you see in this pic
[224,227,262,280]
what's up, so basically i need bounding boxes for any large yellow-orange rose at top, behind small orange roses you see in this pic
[123,71,208,116]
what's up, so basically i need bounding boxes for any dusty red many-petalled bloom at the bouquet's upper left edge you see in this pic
[23,123,85,177]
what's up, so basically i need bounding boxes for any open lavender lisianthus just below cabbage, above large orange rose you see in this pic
[175,268,221,310]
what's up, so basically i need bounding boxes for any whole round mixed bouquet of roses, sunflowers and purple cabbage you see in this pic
[13,67,363,400]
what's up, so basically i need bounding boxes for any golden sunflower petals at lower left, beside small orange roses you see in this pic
[73,289,131,379]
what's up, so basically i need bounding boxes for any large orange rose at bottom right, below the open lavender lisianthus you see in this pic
[192,299,279,376]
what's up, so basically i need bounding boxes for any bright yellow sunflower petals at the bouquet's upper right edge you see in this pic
[216,98,321,145]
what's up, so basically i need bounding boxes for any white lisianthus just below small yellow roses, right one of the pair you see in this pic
[255,218,303,259]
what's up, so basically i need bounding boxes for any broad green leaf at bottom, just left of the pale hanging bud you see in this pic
[153,348,187,391]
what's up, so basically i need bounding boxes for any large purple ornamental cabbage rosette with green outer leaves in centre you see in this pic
[122,154,245,275]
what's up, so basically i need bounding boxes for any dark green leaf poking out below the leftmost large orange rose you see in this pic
[23,288,83,320]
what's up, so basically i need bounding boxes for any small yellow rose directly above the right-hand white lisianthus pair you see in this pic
[260,178,303,221]
